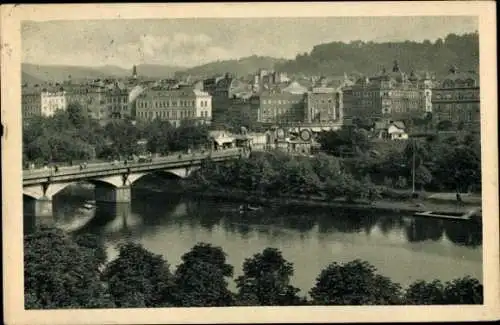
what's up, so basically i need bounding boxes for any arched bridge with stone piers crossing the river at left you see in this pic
[23,148,248,216]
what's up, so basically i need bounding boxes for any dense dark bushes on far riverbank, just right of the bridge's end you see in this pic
[190,151,377,201]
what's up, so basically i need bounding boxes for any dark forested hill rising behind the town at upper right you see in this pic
[275,32,479,77]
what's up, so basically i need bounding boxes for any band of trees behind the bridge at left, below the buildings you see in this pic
[23,103,208,165]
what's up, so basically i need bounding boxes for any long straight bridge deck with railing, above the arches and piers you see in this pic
[23,149,241,184]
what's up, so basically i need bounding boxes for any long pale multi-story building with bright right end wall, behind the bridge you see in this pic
[136,87,212,127]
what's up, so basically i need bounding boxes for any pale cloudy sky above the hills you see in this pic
[21,16,478,69]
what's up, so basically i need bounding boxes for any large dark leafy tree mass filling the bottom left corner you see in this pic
[24,228,114,309]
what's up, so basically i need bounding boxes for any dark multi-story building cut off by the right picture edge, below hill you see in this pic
[432,67,481,130]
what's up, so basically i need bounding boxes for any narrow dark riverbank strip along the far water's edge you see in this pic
[136,184,481,218]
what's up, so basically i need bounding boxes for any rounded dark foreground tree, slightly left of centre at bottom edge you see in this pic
[174,243,233,307]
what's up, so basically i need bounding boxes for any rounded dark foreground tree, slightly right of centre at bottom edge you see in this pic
[236,247,304,306]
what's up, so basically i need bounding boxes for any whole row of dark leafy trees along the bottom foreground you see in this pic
[24,228,483,309]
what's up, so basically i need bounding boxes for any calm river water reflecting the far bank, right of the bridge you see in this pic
[28,185,482,294]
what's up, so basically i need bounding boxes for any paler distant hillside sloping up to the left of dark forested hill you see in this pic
[176,55,285,77]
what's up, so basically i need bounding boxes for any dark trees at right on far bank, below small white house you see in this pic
[318,127,481,192]
